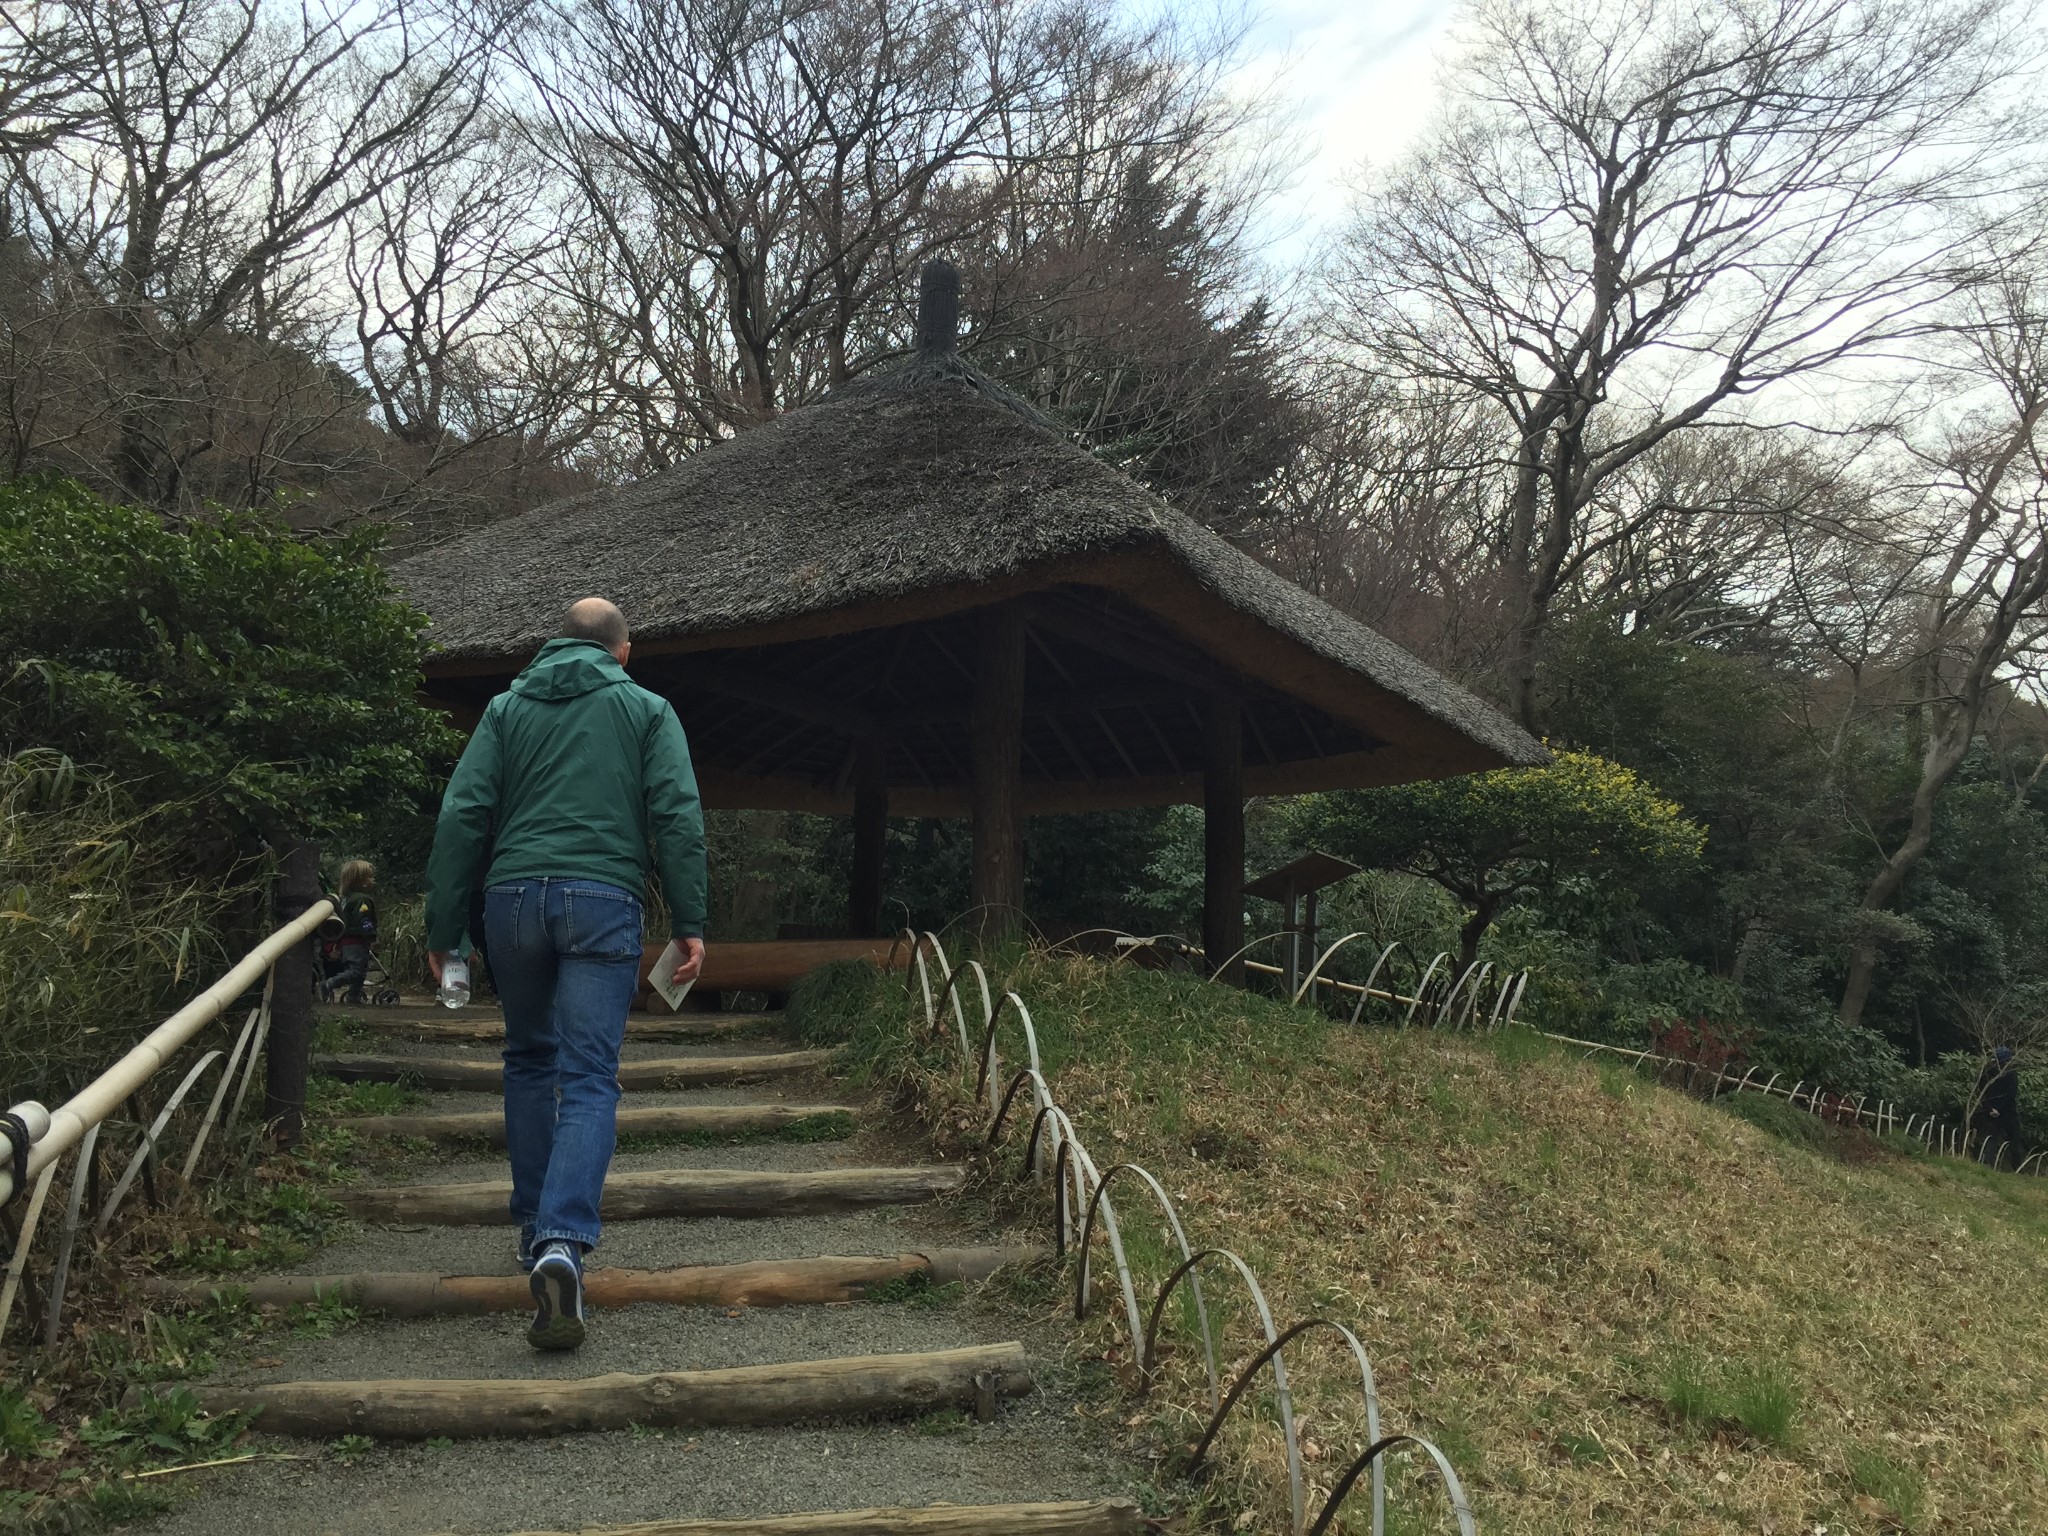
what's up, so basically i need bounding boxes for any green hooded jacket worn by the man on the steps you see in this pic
[426,639,705,950]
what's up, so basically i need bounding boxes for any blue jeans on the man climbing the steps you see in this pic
[483,881,641,1249]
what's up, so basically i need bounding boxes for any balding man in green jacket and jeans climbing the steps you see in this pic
[426,598,705,1350]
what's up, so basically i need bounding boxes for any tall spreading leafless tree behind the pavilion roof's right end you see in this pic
[1329,0,2017,727]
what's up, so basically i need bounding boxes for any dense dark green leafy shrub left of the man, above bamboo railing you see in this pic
[0,479,455,864]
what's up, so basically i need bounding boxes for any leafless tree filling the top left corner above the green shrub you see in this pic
[0,0,495,508]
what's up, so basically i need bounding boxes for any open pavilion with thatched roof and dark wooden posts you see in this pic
[397,264,1544,966]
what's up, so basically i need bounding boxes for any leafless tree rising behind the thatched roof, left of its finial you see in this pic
[522,0,1049,465]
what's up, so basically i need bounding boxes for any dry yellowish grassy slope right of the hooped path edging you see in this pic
[790,958,2048,1536]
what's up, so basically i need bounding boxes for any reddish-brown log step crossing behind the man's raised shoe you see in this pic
[143,1247,1044,1317]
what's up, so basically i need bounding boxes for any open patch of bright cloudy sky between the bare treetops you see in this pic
[1243,0,1456,266]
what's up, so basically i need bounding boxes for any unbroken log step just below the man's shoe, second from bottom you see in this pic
[161,1343,1032,1440]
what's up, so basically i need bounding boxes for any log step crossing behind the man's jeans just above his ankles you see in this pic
[336,1165,963,1227]
